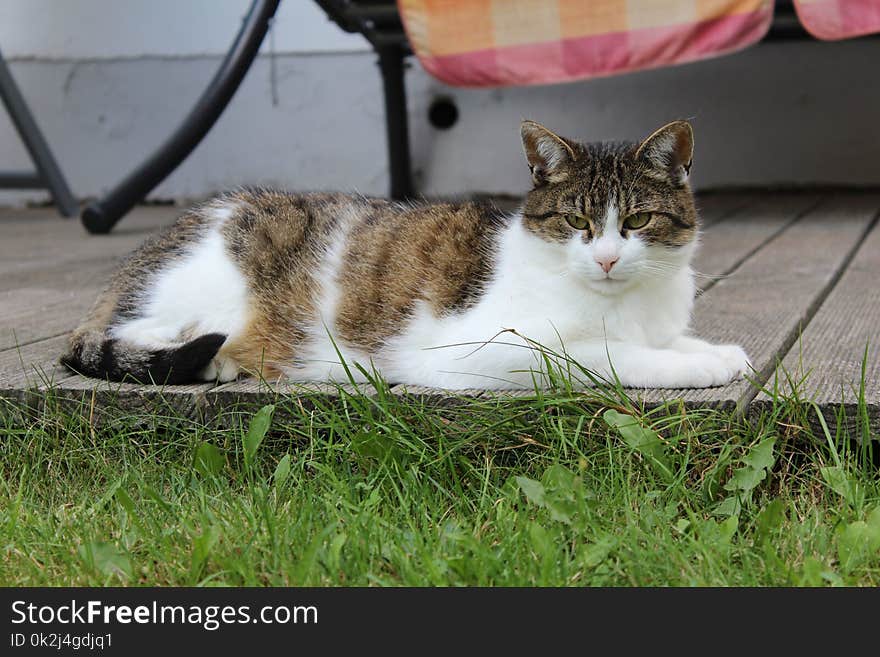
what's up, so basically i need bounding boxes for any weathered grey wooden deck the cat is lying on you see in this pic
[0,192,880,434]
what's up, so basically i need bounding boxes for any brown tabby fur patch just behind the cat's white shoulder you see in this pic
[336,203,504,350]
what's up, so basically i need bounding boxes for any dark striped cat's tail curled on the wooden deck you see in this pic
[61,331,226,385]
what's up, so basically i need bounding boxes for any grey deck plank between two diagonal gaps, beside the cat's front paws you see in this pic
[633,196,880,412]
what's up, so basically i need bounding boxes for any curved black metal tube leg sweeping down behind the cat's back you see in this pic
[81,0,281,233]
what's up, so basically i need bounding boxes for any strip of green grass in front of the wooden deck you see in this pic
[0,366,880,586]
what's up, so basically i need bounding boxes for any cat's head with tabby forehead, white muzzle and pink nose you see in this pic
[522,121,698,294]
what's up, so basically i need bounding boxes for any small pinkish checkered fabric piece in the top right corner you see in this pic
[794,0,880,41]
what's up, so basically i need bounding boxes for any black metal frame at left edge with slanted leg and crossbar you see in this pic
[0,47,79,217]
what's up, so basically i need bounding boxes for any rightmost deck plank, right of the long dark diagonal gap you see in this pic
[755,210,880,438]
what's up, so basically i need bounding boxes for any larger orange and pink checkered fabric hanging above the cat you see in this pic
[398,0,772,87]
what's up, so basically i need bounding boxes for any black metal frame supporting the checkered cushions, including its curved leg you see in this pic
[82,0,868,233]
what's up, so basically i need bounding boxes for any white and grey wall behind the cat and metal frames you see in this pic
[0,0,880,204]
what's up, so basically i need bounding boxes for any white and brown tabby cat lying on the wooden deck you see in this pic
[62,121,749,389]
